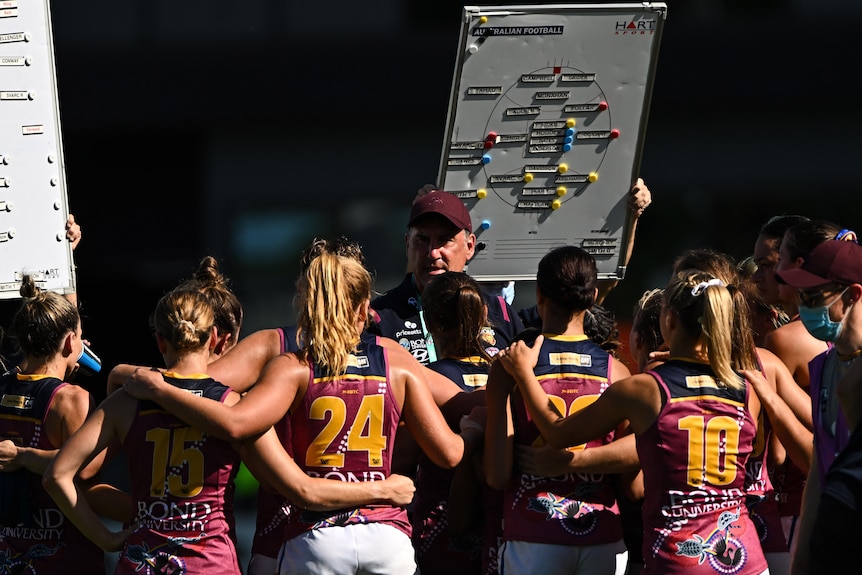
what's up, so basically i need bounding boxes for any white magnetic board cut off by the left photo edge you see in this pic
[0,0,75,298]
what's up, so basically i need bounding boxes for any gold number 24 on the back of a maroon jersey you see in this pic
[305,395,388,467]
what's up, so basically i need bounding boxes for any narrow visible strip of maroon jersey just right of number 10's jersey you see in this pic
[745,354,789,553]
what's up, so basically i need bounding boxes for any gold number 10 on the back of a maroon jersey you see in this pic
[678,415,739,487]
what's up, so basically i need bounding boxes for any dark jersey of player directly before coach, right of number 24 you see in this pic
[410,357,490,575]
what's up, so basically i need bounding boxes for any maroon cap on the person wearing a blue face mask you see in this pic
[776,240,862,289]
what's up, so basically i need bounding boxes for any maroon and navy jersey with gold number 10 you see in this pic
[637,359,767,575]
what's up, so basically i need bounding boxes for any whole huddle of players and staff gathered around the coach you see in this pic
[0,186,862,575]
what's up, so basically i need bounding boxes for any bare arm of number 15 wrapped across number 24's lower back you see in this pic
[242,428,416,511]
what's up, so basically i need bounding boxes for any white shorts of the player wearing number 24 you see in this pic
[278,523,419,575]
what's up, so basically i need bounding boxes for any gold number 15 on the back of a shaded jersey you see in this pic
[147,427,204,498]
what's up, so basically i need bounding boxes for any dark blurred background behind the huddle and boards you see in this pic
[52,0,862,404]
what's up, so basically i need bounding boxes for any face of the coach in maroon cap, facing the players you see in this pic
[405,214,476,292]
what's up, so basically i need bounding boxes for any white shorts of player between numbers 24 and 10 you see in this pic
[498,539,629,575]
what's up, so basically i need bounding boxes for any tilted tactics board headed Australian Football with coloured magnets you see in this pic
[438,2,667,280]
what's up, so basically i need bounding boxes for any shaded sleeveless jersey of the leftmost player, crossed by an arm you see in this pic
[0,372,105,574]
